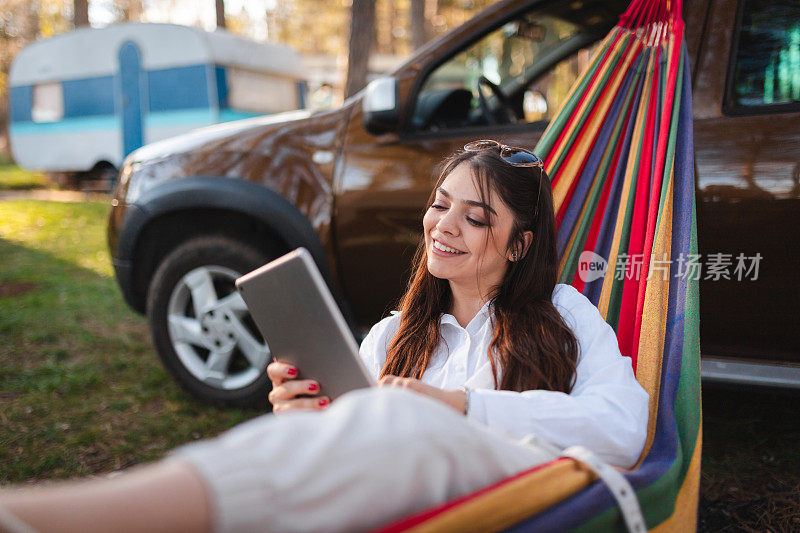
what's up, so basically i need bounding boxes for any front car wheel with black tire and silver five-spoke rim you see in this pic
[147,236,279,407]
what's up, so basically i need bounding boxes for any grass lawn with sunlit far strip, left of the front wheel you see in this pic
[0,200,259,483]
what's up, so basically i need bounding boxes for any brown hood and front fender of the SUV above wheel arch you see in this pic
[113,103,353,233]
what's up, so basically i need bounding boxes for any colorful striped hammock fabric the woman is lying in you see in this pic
[378,0,701,532]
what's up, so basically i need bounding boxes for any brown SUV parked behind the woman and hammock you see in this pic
[109,0,800,404]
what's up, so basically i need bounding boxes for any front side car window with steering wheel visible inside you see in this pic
[412,13,590,131]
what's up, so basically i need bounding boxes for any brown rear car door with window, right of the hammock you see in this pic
[694,0,800,362]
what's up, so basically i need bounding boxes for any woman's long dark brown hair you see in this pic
[381,149,578,393]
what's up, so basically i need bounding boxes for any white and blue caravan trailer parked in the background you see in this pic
[9,24,306,177]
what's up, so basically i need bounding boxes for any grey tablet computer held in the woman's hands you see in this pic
[236,248,375,399]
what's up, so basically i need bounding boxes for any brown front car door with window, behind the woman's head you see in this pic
[334,1,622,327]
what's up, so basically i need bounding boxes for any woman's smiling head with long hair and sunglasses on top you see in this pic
[382,145,577,392]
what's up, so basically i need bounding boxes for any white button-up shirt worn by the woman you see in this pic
[360,284,648,466]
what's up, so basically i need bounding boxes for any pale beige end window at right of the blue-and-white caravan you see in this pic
[226,68,300,113]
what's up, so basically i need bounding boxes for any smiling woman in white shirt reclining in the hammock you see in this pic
[0,143,648,531]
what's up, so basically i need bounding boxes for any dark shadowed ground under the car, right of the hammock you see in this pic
[698,384,800,532]
